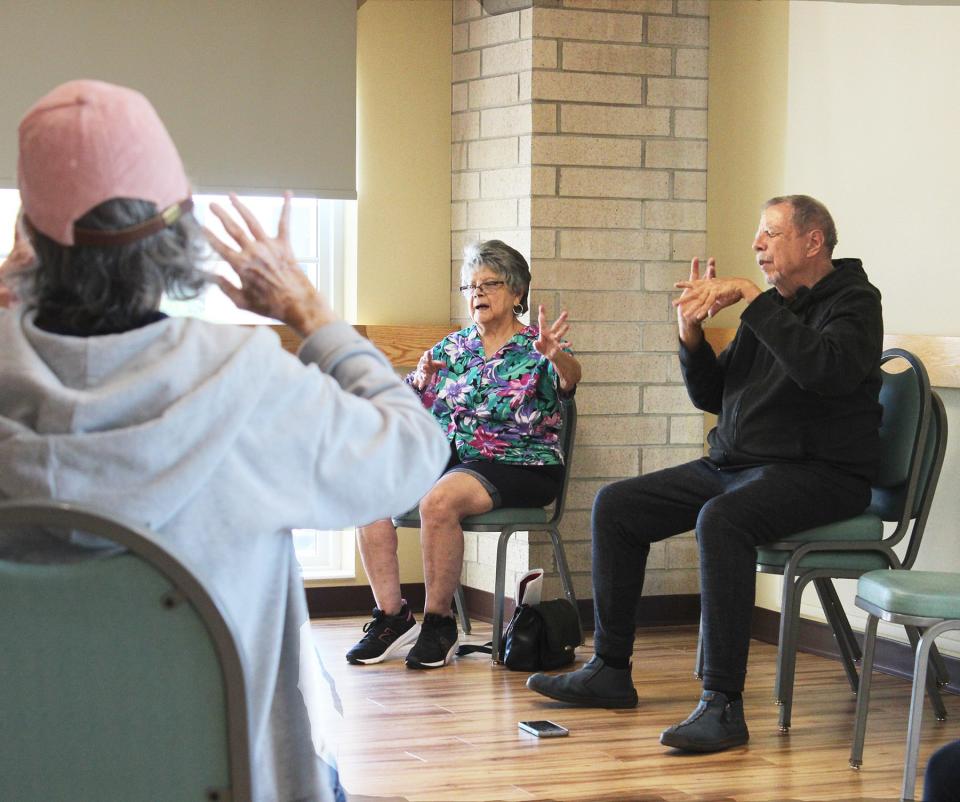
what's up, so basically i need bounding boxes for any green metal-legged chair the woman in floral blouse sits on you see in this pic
[393,398,577,661]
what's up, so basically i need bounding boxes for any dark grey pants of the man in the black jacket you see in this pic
[592,459,870,691]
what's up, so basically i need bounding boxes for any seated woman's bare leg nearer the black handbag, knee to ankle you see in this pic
[420,471,493,615]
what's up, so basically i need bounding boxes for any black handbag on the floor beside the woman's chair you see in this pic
[500,599,583,671]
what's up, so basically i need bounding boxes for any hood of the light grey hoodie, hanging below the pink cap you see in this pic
[0,310,284,528]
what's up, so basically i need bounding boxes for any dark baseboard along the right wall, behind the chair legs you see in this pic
[751,607,960,694]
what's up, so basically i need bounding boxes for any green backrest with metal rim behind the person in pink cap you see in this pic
[0,502,251,802]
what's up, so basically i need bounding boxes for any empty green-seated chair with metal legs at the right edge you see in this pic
[850,571,960,802]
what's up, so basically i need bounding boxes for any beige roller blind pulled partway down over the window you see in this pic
[0,0,357,198]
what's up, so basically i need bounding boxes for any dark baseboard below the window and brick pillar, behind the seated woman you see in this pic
[306,583,700,631]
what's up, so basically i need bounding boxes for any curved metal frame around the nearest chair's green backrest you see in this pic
[0,499,252,802]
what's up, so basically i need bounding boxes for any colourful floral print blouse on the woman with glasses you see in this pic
[406,325,563,465]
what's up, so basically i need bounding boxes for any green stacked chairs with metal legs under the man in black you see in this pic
[696,348,947,732]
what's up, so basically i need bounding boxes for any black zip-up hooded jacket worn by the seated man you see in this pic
[680,259,883,482]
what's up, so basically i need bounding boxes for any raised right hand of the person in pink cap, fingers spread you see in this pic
[204,192,336,337]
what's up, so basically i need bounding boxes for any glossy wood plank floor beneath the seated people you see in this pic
[313,619,960,802]
